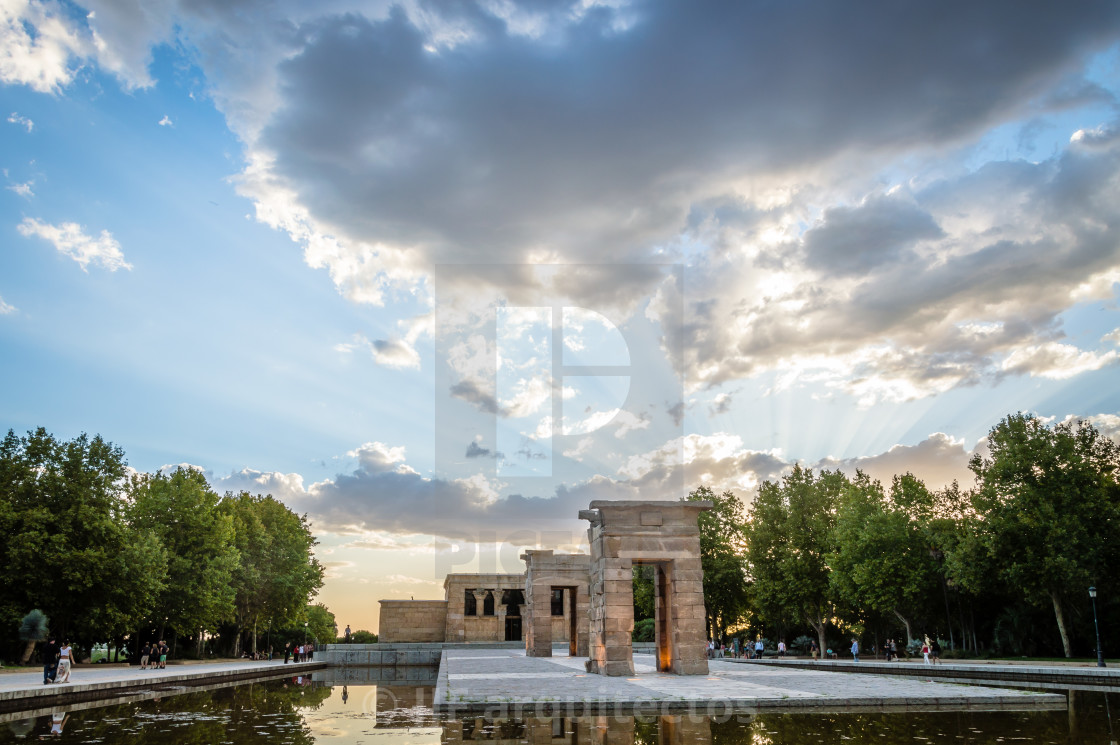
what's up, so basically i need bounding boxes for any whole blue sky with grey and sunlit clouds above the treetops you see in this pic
[0,0,1120,630]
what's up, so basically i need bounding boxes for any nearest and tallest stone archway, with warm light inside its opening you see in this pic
[579,501,712,676]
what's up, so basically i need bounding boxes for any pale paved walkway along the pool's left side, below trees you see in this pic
[0,660,326,711]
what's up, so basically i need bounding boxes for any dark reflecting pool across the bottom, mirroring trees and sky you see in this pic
[0,678,1120,745]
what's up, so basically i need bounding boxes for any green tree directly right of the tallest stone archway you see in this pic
[687,486,747,639]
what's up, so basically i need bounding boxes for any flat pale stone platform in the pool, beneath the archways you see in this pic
[433,649,1066,717]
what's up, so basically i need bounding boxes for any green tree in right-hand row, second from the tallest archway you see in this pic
[746,465,848,650]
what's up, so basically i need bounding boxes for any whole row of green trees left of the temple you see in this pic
[0,428,334,654]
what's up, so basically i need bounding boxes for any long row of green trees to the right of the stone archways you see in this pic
[689,413,1120,656]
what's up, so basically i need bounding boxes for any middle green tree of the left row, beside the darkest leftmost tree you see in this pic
[129,467,239,642]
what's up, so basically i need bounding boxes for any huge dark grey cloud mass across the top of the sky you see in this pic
[261,1,1120,261]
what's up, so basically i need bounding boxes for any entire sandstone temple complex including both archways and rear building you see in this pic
[379,501,711,676]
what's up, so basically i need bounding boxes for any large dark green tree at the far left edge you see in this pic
[0,428,166,643]
